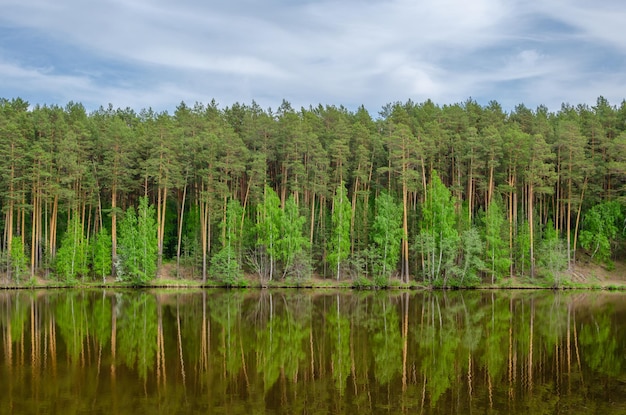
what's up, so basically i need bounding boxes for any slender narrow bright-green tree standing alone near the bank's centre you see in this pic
[327,183,352,280]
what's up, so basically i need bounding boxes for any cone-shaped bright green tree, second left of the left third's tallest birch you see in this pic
[55,215,89,282]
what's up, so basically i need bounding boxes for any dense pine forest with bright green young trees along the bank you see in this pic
[0,97,626,286]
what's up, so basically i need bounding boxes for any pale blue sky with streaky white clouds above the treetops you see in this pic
[0,0,626,114]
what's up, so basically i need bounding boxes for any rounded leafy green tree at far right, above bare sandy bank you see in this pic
[580,201,624,264]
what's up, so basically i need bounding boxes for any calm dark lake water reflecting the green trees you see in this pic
[0,290,626,414]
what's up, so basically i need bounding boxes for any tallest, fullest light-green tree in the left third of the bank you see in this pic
[116,197,158,284]
